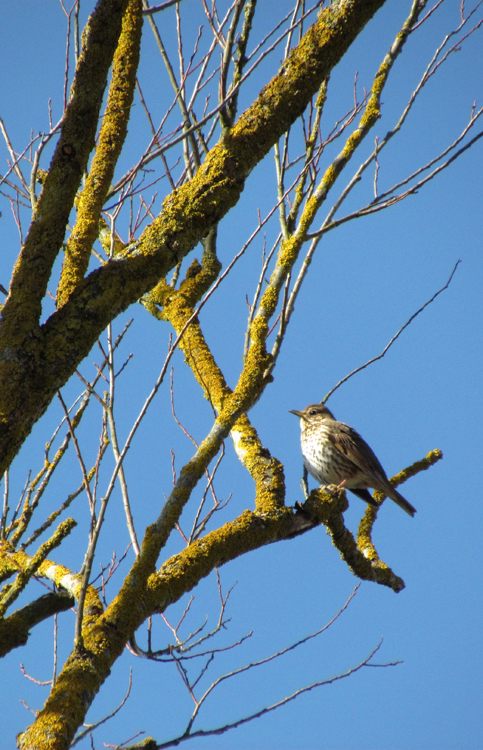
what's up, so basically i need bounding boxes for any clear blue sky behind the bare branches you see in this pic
[0,0,483,750]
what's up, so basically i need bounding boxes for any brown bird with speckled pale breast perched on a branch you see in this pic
[290,404,416,516]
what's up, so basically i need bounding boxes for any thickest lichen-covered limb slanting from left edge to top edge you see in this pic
[0,0,390,482]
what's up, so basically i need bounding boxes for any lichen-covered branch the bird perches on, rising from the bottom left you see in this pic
[20,434,440,750]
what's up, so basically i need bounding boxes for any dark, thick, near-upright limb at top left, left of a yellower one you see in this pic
[0,0,132,346]
